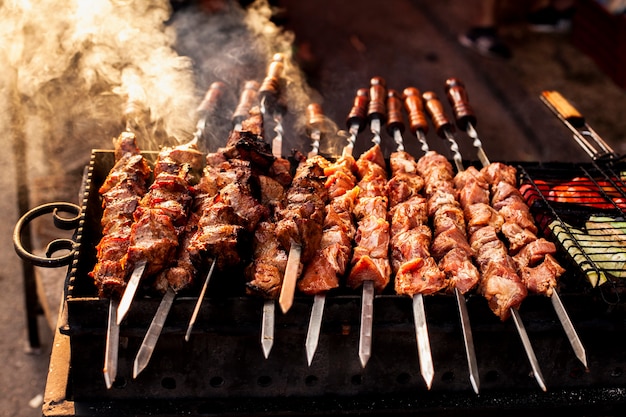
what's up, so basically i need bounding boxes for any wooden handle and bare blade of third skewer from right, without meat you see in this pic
[403,87,480,394]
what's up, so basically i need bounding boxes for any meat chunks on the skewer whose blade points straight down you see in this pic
[346,145,391,292]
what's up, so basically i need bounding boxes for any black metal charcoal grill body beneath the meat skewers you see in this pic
[16,144,626,416]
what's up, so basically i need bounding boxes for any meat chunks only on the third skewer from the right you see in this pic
[417,151,480,294]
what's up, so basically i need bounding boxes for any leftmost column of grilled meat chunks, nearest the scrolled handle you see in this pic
[89,132,151,297]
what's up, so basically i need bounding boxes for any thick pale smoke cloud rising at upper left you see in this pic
[0,0,316,206]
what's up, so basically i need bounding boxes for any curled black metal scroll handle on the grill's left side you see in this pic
[13,202,83,268]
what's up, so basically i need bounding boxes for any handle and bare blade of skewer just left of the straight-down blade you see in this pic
[305,88,369,366]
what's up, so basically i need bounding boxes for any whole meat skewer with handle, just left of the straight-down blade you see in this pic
[298,96,367,366]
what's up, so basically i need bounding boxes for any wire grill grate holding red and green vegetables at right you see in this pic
[518,158,626,303]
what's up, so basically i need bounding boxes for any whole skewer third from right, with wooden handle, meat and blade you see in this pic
[403,87,480,394]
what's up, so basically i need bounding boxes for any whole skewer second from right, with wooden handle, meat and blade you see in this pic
[422,92,547,391]
